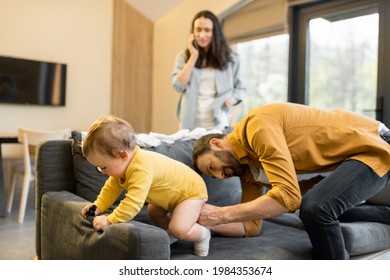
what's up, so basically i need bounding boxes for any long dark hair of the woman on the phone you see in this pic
[186,10,232,70]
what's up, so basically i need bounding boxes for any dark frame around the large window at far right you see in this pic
[288,0,390,126]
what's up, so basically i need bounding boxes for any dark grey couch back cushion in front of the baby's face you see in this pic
[72,131,124,204]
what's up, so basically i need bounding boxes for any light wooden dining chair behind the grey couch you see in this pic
[7,128,71,224]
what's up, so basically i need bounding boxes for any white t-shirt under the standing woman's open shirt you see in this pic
[196,68,229,129]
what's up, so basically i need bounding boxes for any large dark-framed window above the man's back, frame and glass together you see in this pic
[289,0,390,125]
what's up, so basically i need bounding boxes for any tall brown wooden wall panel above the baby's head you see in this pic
[111,0,153,133]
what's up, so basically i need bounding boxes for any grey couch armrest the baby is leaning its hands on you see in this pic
[40,191,170,260]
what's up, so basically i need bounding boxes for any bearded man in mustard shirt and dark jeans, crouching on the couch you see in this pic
[193,103,390,259]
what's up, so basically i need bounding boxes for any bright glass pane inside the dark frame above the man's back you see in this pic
[307,13,379,118]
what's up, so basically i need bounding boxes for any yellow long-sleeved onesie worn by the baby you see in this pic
[94,146,208,224]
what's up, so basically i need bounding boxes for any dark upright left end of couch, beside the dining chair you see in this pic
[35,140,76,258]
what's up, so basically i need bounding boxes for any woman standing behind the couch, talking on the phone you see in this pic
[172,11,245,130]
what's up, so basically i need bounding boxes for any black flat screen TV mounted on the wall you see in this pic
[0,56,67,106]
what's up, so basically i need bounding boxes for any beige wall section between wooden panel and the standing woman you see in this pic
[152,0,239,134]
